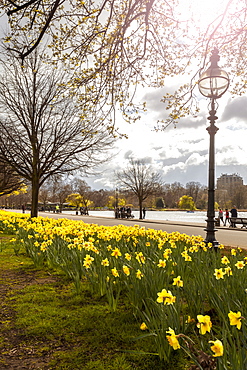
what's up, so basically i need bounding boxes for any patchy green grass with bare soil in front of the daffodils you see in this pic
[0,235,190,370]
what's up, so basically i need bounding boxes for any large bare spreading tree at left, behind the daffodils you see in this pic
[0,49,114,217]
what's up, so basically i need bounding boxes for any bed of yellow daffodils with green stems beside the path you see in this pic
[0,211,247,370]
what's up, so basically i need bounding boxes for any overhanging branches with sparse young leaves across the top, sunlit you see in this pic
[0,0,247,128]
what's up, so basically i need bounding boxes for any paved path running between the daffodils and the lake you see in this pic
[36,212,247,249]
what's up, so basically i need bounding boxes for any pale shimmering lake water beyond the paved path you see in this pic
[63,210,247,223]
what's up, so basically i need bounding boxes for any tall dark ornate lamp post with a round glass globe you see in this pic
[198,48,230,248]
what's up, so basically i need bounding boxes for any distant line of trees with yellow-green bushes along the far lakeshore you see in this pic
[0,172,247,210]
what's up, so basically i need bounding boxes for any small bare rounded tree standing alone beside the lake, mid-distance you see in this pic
[116,159,162,219]
